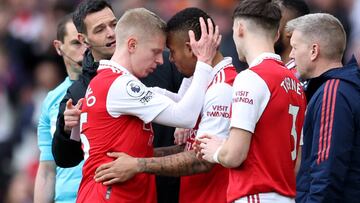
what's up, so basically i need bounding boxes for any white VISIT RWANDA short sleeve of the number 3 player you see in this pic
[230,70,270,133]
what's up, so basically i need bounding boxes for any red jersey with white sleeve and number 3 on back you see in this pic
[228,53,306,202]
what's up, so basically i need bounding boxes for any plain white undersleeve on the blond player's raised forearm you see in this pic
[153,61,212,128]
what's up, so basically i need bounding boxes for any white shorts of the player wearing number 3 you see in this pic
[234,192,295,203]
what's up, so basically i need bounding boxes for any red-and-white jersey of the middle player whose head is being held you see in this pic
[179,58,237,203]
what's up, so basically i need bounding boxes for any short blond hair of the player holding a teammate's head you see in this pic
[115,8,166,43]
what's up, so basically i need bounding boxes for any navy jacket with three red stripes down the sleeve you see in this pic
[296,57,360,203]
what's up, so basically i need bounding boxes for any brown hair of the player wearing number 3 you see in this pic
[233,0,281,37]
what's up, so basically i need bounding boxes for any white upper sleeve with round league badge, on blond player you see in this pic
[106,75,174,123]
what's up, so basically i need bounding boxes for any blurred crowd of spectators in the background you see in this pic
[0,0,360,203]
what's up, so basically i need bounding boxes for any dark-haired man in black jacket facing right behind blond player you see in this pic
[52,0,182,202]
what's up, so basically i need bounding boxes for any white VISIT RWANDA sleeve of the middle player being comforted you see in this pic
[196,83,232,138]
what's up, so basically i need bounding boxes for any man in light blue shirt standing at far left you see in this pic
[34,14,85,203]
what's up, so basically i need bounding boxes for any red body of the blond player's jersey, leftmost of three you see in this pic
[77,61,156,203]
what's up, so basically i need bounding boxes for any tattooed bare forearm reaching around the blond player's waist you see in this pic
[138,150,213,176]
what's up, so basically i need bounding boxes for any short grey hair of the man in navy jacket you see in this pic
[285,13,346,60]
